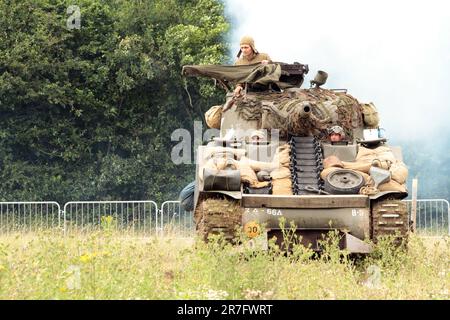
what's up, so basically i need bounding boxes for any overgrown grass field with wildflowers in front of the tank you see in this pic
[0,230,450,300]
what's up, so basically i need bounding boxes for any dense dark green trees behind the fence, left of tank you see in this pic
[0,0,229,202]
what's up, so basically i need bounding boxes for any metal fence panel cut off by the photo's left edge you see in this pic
[0,201,62,234]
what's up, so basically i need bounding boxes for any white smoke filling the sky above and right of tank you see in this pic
[225,0,450,140]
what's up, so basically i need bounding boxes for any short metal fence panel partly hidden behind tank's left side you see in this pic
[160,201,195,238]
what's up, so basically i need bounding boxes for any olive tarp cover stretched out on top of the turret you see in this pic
[182,63,303,89]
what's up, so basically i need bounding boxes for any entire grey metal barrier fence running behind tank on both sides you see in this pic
[0,199,450,237]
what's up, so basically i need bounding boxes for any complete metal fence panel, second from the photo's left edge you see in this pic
[64,201,159,236]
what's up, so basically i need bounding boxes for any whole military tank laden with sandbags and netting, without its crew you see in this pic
[182,62,410,253]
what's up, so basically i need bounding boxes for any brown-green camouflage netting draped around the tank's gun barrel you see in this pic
[230,88,363,139]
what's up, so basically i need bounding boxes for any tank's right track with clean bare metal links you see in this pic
[371,199,409,244]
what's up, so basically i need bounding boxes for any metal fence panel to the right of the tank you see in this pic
[405,199,450,236]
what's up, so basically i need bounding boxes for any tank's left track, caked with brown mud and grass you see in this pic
[194,197,243,242]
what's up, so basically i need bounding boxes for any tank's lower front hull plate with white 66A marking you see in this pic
[241,195,371,253]
